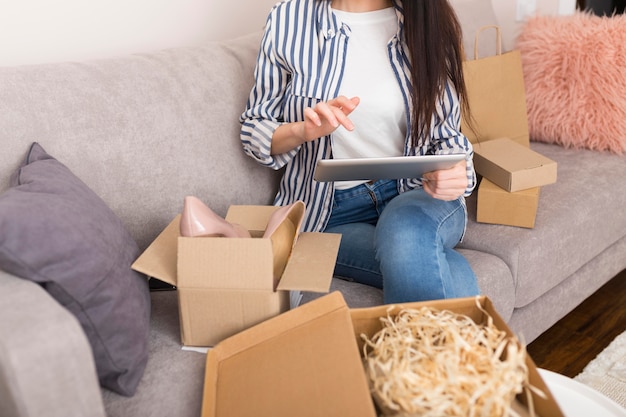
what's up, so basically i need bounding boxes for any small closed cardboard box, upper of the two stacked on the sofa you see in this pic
[474,138,557,192]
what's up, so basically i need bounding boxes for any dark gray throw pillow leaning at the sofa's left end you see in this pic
[0,143,150,396]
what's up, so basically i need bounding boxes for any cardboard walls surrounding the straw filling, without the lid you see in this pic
[350,296,564,417]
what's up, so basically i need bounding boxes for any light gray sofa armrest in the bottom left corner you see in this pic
[0,271,105,417]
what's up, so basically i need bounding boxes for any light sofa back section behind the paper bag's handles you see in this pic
[450,0,500,59]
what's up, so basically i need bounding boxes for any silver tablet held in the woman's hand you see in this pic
[314,154,465,182]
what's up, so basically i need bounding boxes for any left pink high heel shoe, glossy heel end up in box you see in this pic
[180,196,250,237]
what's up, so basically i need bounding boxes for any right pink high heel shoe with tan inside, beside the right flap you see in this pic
[263,201,306,288]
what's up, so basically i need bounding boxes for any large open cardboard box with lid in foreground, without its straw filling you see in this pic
[202,292,563,417]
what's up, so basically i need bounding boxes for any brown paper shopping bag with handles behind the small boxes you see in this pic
[461,26,529,146]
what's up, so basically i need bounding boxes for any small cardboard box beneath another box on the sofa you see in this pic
[476,178,541,229]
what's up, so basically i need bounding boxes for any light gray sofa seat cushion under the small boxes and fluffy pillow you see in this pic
[459,142,626,308]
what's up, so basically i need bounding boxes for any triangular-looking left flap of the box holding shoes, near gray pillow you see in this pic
[131,215,180,286]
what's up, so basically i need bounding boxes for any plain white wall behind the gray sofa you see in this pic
[0,0,575,66]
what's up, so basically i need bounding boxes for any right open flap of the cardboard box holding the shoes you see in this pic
[278,232,341,293]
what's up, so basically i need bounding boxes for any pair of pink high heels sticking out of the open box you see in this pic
[180,196,305,238]
